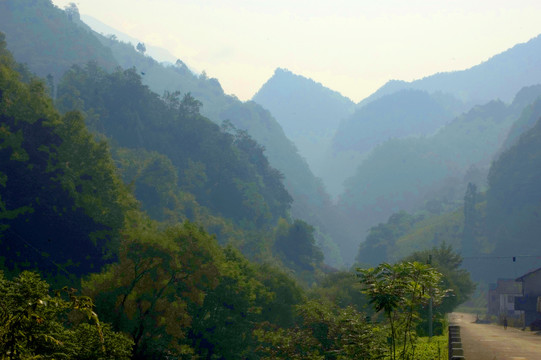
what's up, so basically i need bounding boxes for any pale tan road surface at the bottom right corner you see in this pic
[449,313,541,360]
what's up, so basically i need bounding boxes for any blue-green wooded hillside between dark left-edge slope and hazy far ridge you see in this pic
[58,63,291,227]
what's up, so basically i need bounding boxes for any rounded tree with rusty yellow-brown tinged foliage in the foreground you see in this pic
[83,219,219,359]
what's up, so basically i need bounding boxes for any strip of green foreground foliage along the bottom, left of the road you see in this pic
[0,264,454,360]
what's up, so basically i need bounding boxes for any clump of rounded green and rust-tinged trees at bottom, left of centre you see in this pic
[83,219,303,359]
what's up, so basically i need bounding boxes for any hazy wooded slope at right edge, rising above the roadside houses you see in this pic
[358,95,541,283]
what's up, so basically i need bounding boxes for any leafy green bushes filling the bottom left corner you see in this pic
[0,271,133,360]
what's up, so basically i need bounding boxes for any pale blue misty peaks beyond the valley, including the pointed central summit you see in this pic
[250,31,541,261]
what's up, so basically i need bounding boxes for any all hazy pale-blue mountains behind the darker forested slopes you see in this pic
[4,0,541,265]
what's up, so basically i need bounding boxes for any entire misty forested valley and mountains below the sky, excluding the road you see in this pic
[0,0,541,360]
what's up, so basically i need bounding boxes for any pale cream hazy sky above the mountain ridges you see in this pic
[53,0,541,102]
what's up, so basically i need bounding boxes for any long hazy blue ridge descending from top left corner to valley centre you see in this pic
[0,0,343,266]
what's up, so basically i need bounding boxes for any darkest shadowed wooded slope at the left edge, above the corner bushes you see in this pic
[0,33,137,278]
